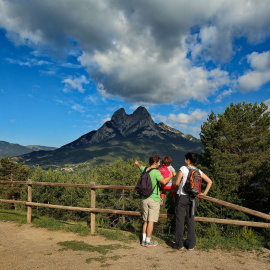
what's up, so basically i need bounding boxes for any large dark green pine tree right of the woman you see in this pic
[199,102,270,219]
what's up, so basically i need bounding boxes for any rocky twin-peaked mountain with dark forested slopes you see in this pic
[13,107,203,166]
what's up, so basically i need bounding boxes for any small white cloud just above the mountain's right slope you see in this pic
[169,109,208,124]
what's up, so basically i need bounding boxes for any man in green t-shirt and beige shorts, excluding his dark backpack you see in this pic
[135,155,173,247]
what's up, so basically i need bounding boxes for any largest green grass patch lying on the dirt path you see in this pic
[57,241,131,255]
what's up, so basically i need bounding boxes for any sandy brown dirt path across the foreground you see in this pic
[0,222,270,270]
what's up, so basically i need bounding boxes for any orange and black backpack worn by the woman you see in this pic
[183,167,202,197]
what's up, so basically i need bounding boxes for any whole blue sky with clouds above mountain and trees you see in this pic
[0,0,270,147]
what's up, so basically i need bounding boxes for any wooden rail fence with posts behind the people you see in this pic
[0,180,270,233]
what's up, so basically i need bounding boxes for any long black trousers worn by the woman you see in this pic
[175,195,197,249]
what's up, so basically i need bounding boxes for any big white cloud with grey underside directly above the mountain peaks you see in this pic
[79,46,230,105]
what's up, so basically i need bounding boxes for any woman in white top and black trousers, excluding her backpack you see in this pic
[174,152,212,250]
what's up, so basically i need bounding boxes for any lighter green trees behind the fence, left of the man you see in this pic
[17,158,146,229]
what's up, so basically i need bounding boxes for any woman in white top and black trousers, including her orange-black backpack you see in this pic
[174,152,212,251]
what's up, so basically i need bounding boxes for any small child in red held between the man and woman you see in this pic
[159,156,176,205]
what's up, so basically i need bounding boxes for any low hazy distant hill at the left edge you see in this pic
[0,141,57,158]
